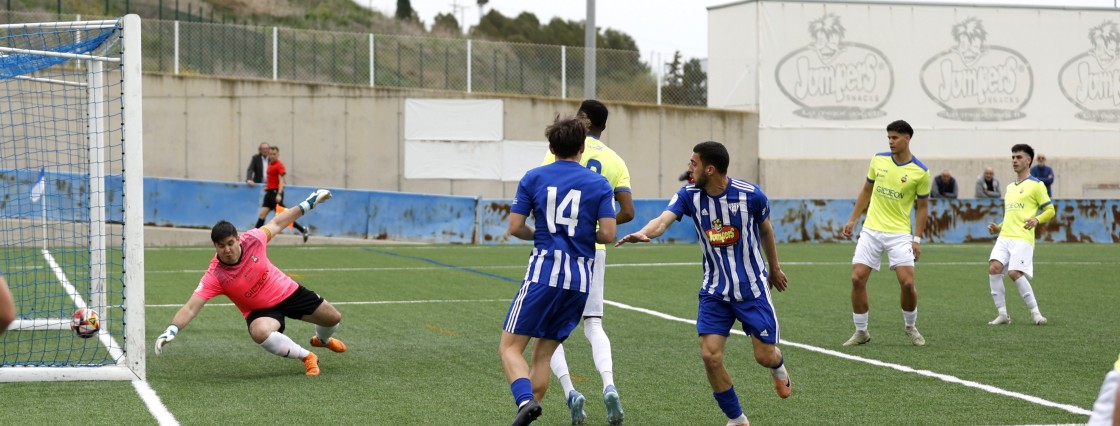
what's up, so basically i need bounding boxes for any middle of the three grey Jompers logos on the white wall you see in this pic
[922,18,1034,121]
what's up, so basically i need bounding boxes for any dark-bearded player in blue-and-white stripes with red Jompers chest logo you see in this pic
[615,141,793,425]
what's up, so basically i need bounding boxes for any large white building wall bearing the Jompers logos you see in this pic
[708,0,1120,197]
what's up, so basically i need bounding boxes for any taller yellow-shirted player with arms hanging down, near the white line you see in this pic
[843,120,931,346]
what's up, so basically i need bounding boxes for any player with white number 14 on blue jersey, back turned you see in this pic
[498,113,616,426]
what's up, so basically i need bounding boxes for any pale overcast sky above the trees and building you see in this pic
[354,0,1117,62]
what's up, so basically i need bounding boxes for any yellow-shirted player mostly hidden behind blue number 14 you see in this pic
[542,99,634,425]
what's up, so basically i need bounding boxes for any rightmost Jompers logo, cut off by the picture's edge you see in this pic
[1057,21,1120,123]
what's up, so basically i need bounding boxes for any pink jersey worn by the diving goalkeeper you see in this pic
[195,228,299,317]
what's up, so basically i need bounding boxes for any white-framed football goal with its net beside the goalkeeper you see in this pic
[0,15,146,381]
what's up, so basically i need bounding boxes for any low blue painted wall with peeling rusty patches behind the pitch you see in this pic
[0,169,1120,244]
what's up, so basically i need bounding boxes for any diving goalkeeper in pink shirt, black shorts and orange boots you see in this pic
[156,189,346,376]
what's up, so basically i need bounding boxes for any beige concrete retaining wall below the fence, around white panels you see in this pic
[143,74,758,197]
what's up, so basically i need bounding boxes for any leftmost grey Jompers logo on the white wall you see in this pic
[774,13,894,120]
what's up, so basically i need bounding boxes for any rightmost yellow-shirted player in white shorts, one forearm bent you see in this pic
[988,143,1055,325]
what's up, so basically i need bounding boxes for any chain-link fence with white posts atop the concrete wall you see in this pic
[0,12,707,105]
